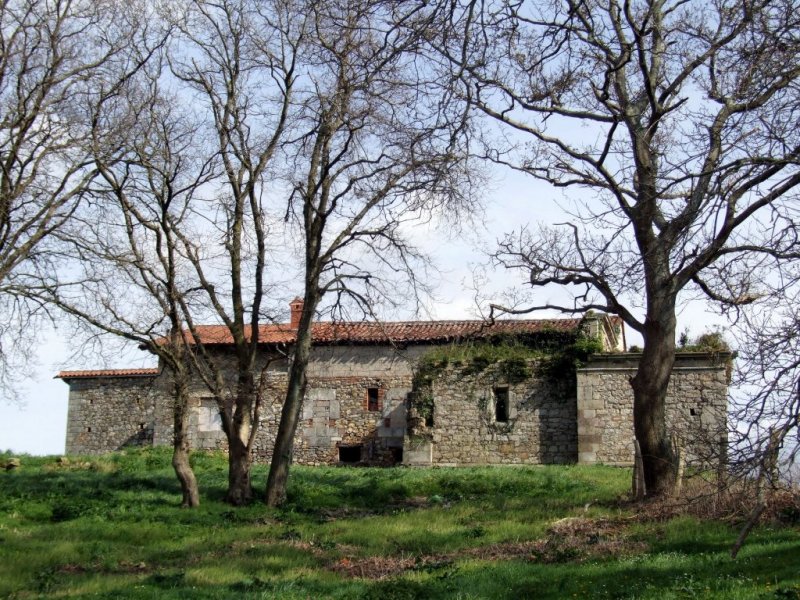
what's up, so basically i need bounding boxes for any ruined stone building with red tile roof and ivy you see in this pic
[58,300,730,465]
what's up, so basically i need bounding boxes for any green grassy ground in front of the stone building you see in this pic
[0,449,800,599]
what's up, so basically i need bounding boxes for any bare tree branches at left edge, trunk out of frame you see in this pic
[0,0,161,398]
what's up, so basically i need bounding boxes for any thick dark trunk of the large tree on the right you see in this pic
[631,302,676,496]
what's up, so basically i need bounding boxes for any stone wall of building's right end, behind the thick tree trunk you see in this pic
[577,352,733,465]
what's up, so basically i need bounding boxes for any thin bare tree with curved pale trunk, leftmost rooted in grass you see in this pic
[35,70,216,507]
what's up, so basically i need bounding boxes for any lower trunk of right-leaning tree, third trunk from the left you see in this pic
[266,297,316,506]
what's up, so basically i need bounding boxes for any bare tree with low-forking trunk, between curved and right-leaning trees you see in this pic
[170,0,305,505]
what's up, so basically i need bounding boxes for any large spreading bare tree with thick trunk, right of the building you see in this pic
[437,0,800,495]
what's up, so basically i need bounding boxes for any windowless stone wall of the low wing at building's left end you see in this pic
[66,376,162,454]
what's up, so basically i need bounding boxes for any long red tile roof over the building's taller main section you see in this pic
[181,319,581,345]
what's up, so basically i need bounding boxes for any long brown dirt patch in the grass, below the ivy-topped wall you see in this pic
[329,518,647,579]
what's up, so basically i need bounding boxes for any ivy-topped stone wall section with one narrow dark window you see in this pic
[405,360,578,465]
